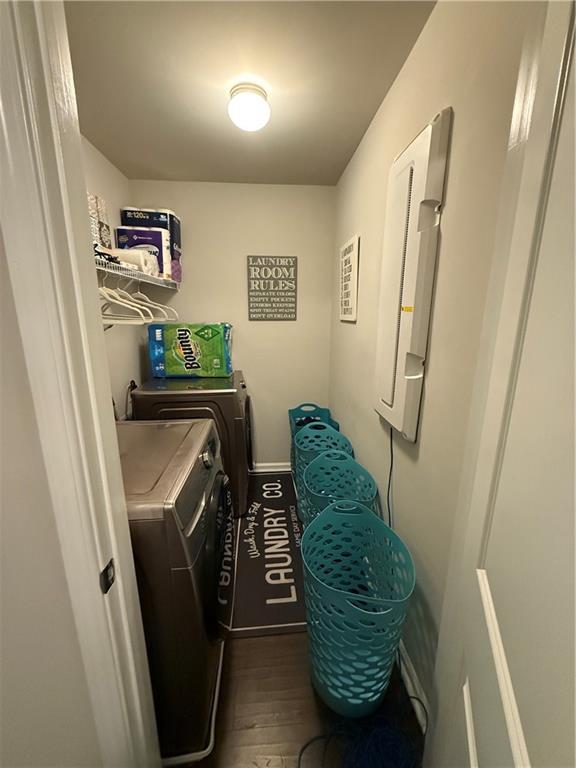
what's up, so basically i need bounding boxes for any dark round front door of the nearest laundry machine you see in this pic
[203,472,236,638]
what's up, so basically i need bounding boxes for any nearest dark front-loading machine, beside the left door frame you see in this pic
[117,420,235,766]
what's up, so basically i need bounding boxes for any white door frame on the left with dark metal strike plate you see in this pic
[0,2,160,768]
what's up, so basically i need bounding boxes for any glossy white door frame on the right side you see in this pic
[425,2,574,768]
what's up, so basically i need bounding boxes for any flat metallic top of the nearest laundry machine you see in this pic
[116,419,212,518]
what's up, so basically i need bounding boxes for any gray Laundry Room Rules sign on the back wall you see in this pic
[248,256,298,320]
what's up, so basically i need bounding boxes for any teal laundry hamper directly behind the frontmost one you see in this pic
[301,451,380,526]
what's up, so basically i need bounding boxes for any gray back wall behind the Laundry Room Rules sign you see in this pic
[132,181,335,462]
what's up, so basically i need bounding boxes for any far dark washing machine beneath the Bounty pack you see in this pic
[132,371,253,517]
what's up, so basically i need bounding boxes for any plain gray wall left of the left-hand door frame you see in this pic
[0,235,101,768]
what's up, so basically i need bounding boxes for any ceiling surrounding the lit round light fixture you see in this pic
[66,0,433,184]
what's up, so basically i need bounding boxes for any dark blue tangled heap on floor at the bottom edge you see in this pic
[342,725,420,768]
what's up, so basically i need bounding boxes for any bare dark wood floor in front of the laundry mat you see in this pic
[197,632,423,768]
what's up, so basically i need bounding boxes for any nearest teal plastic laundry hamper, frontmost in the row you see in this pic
[302,501,416,717]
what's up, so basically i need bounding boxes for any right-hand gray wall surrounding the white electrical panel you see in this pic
[330,2,535,693]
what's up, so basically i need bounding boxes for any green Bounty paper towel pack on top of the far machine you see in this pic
[148,323,232,379]
